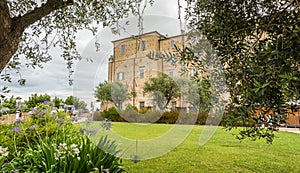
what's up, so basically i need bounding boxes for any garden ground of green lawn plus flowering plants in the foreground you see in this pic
[0,104,300,173]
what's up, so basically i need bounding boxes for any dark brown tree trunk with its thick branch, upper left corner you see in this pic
[0,0,73,72]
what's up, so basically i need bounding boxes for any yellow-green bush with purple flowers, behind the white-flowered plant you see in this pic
[0,109,79,162]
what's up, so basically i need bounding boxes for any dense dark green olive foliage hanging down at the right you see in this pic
[186,0,300,142]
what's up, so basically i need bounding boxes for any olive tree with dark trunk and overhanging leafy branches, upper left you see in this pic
[0,0,152,84]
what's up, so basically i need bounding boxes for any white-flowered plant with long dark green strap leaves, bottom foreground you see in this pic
[3,136,124,173]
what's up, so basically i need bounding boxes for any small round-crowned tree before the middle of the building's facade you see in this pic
[143,74,180,110]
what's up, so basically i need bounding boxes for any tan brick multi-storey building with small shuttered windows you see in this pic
[108,31,186,108]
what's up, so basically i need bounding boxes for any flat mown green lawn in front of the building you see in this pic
[82,123,300,173]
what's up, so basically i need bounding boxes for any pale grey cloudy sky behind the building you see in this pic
[0,0,186,109]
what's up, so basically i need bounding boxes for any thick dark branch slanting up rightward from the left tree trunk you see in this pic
[13,0,74,32]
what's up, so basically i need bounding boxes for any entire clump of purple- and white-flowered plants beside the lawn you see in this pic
[0,106,124,173]
